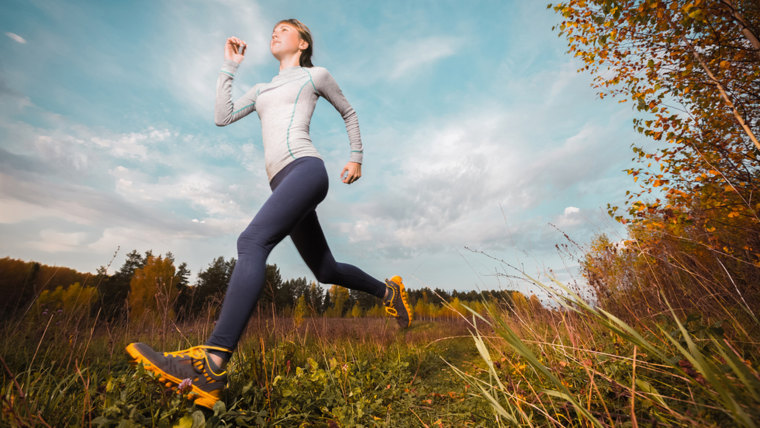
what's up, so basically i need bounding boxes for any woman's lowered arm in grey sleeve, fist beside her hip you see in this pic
[313,67,364,184]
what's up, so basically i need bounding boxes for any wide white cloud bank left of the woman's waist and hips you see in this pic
[0,113,260,252]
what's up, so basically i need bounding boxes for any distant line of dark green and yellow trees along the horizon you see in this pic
[0,250,528,321]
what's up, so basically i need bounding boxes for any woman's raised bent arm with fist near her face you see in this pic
[214,37,258,126]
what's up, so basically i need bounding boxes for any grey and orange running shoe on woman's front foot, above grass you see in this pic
[127,343,230,409]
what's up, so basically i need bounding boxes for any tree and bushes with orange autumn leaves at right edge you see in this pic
[554,0,760,316]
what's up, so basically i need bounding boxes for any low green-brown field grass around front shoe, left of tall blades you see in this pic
[0,313,491,426]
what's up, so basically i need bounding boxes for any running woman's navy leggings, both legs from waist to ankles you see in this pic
[206,157,385,351]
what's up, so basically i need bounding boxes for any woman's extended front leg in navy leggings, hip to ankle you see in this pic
[206,157,328,350]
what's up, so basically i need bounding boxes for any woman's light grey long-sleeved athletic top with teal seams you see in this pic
[214,60,363,181]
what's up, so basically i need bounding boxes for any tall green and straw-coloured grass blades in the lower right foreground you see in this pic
[458,272,760,427]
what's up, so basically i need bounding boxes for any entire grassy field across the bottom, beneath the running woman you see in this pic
[1,280,760,427]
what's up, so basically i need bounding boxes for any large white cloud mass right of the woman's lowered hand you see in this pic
[330,91,625,255]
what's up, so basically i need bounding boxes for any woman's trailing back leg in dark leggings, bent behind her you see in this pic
[290,211,385,299]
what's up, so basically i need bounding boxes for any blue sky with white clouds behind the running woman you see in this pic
[0,0,642,293]
